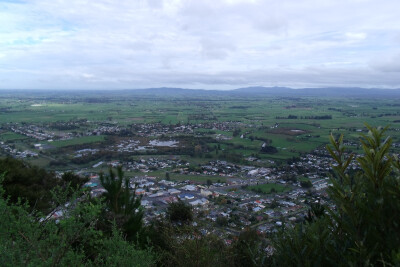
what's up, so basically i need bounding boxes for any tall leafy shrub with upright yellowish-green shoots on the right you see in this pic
[274,126,400,266]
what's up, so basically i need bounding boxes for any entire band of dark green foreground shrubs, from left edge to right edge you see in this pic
[0,127,400,266]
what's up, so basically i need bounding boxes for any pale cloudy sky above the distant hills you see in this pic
[0,0,400,89]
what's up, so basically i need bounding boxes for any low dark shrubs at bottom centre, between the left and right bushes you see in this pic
[141,221,270,267]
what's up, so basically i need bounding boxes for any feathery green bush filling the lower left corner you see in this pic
[0,177,155,266]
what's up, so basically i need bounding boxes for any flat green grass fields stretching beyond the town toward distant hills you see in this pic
[0,92,400,171]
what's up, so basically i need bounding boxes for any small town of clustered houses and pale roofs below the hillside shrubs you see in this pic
[1,121,356,242]
